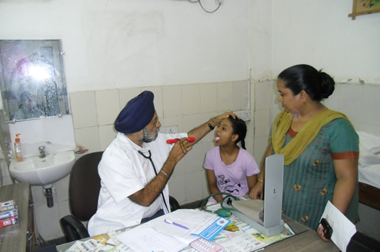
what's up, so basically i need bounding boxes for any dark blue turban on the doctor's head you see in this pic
[115,91,156,133]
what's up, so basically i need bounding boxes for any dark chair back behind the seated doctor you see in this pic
[69,151,103,221]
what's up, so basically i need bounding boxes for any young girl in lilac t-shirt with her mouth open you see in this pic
[204,117,260,203]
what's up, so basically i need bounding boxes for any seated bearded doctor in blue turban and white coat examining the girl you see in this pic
[88,91,236,236]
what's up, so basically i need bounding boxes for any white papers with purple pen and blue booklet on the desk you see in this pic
[118,209,230,252]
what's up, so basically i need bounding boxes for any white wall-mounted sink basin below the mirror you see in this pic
[9,151,75,186]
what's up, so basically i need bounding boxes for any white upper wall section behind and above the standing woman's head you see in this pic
[270,0,380,84]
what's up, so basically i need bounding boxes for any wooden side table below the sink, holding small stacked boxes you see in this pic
[0,183,36,252]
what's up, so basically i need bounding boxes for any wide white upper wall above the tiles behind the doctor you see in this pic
[0,0,250,92]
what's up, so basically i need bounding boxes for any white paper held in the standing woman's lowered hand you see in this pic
[322,201,356,252]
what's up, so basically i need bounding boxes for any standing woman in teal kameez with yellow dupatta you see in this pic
[252,65,359,241]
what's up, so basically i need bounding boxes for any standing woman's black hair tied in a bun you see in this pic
[278,65,335,102]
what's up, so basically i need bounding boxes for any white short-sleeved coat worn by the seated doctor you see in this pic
[88,133,187,236]
